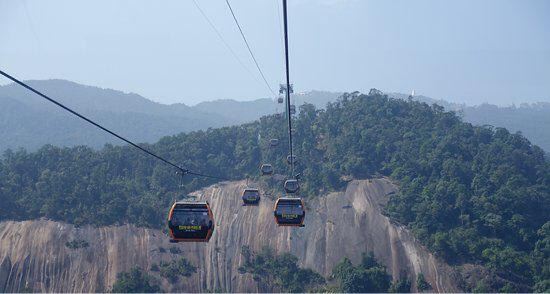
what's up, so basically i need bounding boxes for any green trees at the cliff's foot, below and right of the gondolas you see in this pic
[239,246,416,293]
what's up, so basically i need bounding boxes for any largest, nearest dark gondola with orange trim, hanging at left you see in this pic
[168,201,214,243]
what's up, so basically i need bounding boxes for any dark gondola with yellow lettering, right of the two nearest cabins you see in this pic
[273,197,306,227]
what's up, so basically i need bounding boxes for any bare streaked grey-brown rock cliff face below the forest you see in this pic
[0,179,459,292]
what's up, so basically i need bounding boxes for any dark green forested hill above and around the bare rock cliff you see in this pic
[0,91,550,291]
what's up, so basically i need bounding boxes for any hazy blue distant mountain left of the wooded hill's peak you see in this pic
[0,80,337,151]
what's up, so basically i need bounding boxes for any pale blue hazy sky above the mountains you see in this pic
[0,0,550,105]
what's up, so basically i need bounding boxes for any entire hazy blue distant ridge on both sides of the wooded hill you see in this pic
[0,80,550,152]
